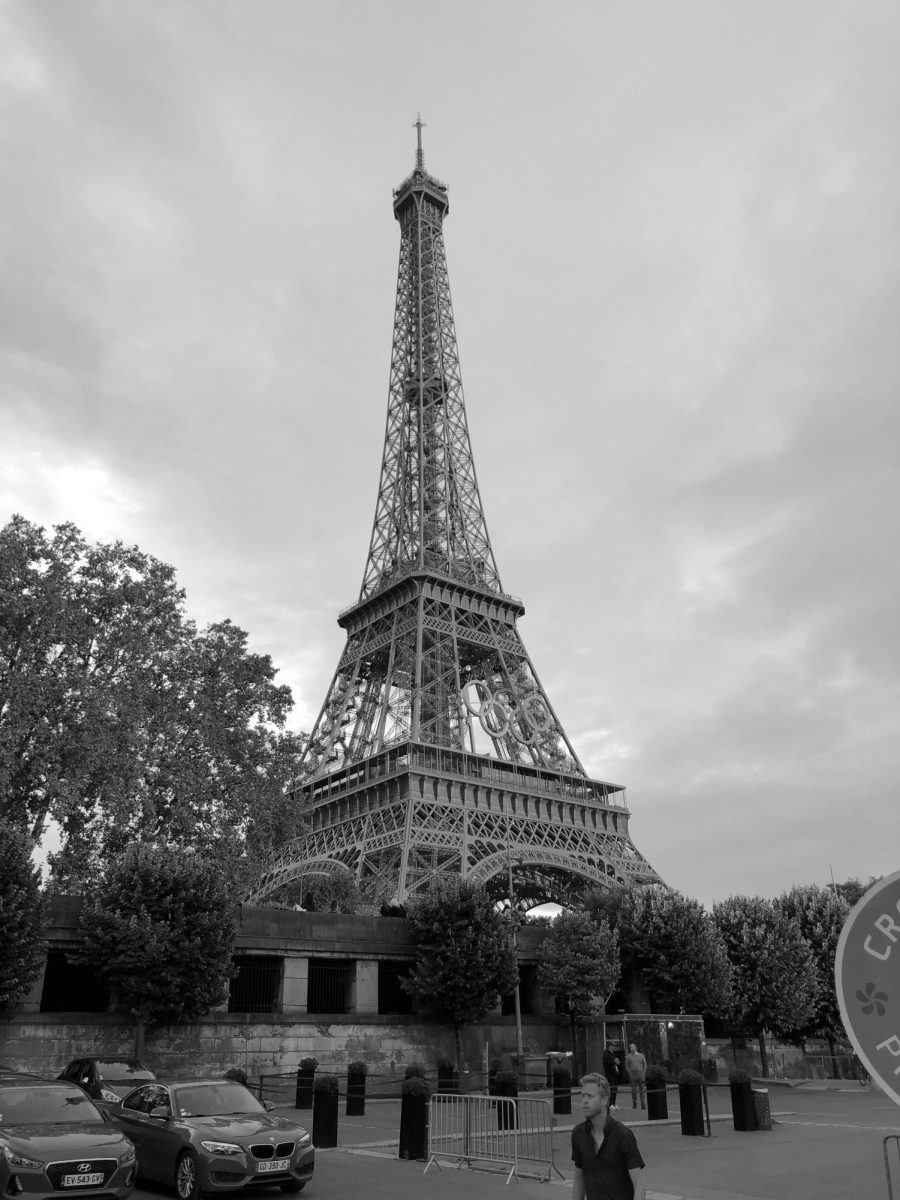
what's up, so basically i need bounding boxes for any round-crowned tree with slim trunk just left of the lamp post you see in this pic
[403,875,518,1070]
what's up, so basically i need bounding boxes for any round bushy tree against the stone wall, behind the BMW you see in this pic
[73,844,238,1057]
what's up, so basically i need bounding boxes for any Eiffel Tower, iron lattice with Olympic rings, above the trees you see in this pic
[250,120,661,907]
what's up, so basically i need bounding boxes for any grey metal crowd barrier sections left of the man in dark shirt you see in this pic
[425,1092,564,1183]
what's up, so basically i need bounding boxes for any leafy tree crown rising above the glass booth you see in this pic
[629,888,734,1015]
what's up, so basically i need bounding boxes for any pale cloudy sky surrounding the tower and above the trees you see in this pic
[0,0,900,904]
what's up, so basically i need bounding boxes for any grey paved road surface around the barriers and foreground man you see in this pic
[134,1087,900,1200]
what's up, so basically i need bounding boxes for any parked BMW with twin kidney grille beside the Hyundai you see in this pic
[106,1079,316,1200]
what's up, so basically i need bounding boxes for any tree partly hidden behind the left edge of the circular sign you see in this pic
[778,883,850,1079]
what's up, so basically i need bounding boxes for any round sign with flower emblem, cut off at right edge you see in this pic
[834,871,900,1104]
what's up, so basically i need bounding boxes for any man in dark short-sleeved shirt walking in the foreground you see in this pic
[572,1074,647,1200]
